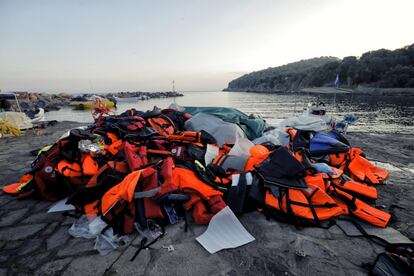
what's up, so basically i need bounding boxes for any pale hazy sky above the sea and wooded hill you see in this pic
[0,0,414,93]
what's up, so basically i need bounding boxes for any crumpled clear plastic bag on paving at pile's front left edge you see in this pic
[69,215,131,256]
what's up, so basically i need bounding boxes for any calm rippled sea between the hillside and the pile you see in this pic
[46,92,414,134]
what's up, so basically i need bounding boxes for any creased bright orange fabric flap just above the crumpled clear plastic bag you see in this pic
[101,170,142,215]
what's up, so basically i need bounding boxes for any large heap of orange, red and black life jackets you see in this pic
[3,105,391,237]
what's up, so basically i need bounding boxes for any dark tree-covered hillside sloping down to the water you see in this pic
[225,44,414,92]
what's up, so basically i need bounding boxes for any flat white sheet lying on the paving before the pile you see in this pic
[196,206,255,254]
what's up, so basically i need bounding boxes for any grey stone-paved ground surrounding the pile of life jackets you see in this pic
[0,122,414,276]
